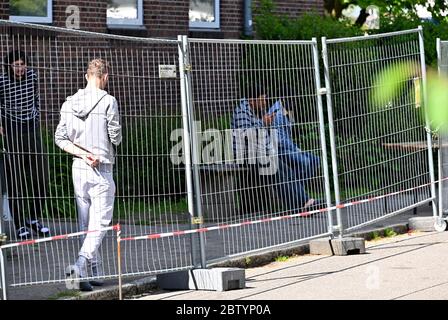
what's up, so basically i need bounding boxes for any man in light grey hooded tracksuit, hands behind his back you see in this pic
[55,59,122,291]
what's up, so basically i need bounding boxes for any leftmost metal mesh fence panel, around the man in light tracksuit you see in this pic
[0,21,192,286]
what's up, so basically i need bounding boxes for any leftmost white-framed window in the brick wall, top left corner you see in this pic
[9,0,53,23]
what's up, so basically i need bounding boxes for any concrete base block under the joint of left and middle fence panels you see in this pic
[157,268,246,291]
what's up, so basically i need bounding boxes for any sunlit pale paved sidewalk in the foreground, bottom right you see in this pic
[135,232,448,300]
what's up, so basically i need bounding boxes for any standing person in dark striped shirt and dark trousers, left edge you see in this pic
[0,50,50,240]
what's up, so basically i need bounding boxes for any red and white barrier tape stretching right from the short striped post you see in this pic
[121,177,448,241]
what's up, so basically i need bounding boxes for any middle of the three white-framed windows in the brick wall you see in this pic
[107,0,143,26]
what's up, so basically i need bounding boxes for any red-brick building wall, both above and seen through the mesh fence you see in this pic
[0,0,323,126]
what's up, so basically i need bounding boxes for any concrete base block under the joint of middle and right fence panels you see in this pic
[310,237,366,256]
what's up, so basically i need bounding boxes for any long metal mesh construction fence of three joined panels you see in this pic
[0,21,435,297]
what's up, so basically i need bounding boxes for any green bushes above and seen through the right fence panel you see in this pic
[254,0,448,198]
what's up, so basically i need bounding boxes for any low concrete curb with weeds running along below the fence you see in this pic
[62,223,409,300]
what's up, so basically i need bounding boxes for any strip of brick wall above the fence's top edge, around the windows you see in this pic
[0,0,324,38]
